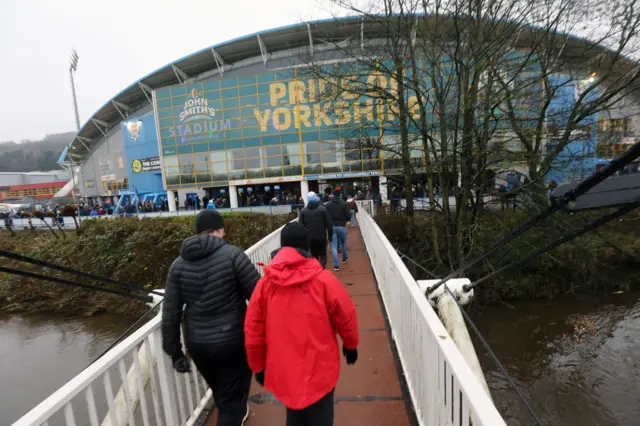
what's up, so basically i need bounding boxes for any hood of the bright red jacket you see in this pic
[264,247,323,286]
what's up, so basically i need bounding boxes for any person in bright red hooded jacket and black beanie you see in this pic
[244,222,360,426]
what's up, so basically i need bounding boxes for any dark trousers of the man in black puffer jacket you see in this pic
[187,342,251,426]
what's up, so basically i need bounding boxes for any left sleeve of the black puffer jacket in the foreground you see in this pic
[162,262,184,356]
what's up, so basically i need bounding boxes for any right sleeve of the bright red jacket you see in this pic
[322,271,360,349]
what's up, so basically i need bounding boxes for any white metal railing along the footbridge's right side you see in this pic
[357,208,506,426]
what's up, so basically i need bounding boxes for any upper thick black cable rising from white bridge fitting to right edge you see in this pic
[427,142,640,294]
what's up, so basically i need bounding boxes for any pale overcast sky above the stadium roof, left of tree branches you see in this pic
[0,0,329,141]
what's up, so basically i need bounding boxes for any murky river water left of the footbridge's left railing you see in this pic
[0,315,133,426]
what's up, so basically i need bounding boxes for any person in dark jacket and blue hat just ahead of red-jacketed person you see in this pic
[298,191,333,268]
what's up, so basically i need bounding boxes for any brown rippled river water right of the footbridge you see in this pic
[473,293,640,426]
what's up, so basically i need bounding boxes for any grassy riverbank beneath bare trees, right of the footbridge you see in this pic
[376,211,640,303]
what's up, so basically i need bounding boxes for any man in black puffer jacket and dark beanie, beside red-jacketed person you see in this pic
[162,210,260,426]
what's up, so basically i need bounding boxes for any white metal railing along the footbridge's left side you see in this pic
[13,221,282,426]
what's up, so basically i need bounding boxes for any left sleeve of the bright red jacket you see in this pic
[244,278,267,373]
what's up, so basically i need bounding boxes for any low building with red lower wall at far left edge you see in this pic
[0,170,70,203]
